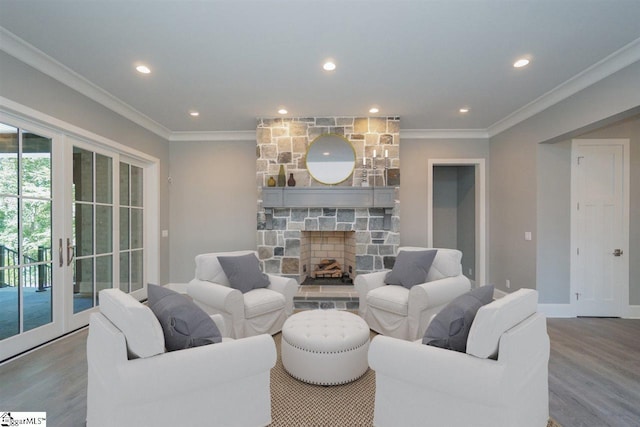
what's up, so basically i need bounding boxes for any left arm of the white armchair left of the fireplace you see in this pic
[187,279,244,317]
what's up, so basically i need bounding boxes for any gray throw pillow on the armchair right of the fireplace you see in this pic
[384,249,438,289]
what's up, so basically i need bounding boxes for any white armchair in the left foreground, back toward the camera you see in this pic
[87,289,276,427]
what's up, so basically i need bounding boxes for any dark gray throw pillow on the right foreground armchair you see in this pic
[422,285,493,353]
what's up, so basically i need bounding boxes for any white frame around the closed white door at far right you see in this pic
[569,138,631,317]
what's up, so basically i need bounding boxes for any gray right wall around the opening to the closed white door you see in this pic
[489,62,640,304]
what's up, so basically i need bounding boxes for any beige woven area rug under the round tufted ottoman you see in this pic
[271,334,561,427]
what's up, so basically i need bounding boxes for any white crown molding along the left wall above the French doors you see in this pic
[0,27,171,139]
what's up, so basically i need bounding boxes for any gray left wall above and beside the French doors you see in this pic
[0,51,169,282]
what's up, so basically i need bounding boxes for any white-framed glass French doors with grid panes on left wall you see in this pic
[0,115,146,361]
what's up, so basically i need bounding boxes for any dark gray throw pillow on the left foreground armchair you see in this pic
[147,284,222,351]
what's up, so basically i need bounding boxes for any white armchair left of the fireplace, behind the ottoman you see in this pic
[187,251,299,338]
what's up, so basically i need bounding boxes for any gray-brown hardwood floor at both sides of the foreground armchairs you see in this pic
[0,319,640,427]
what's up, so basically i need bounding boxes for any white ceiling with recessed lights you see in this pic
[0,0,640,139]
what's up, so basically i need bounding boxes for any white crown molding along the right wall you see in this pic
[487,38,640,137]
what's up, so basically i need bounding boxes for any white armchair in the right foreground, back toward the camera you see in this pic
[369,289,549,427]
